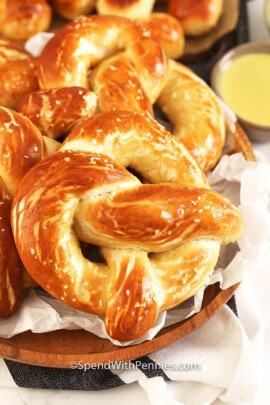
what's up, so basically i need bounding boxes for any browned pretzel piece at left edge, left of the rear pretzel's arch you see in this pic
[0,38,38,108]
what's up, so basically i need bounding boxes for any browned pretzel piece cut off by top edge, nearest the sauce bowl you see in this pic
[168,0,223,37]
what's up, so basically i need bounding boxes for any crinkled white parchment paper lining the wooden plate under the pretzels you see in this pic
[0,34,270,345]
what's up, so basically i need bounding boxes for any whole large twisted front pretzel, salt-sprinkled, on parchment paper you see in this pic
[12,112,242,341]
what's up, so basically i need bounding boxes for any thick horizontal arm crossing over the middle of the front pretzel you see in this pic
[75,184,243,252]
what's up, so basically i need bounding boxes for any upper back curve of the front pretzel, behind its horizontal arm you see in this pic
[61,111,209,188]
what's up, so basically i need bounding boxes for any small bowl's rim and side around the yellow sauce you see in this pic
[211,41,270,142]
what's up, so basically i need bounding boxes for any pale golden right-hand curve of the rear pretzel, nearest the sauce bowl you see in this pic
[157,60,225,171]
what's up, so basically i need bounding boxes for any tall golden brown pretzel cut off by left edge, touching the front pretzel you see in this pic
[0,107,59,317]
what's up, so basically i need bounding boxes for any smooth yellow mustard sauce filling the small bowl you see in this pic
[220,53,270,126]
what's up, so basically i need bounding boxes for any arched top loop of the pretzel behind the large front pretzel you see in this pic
[38,15,167,103]
